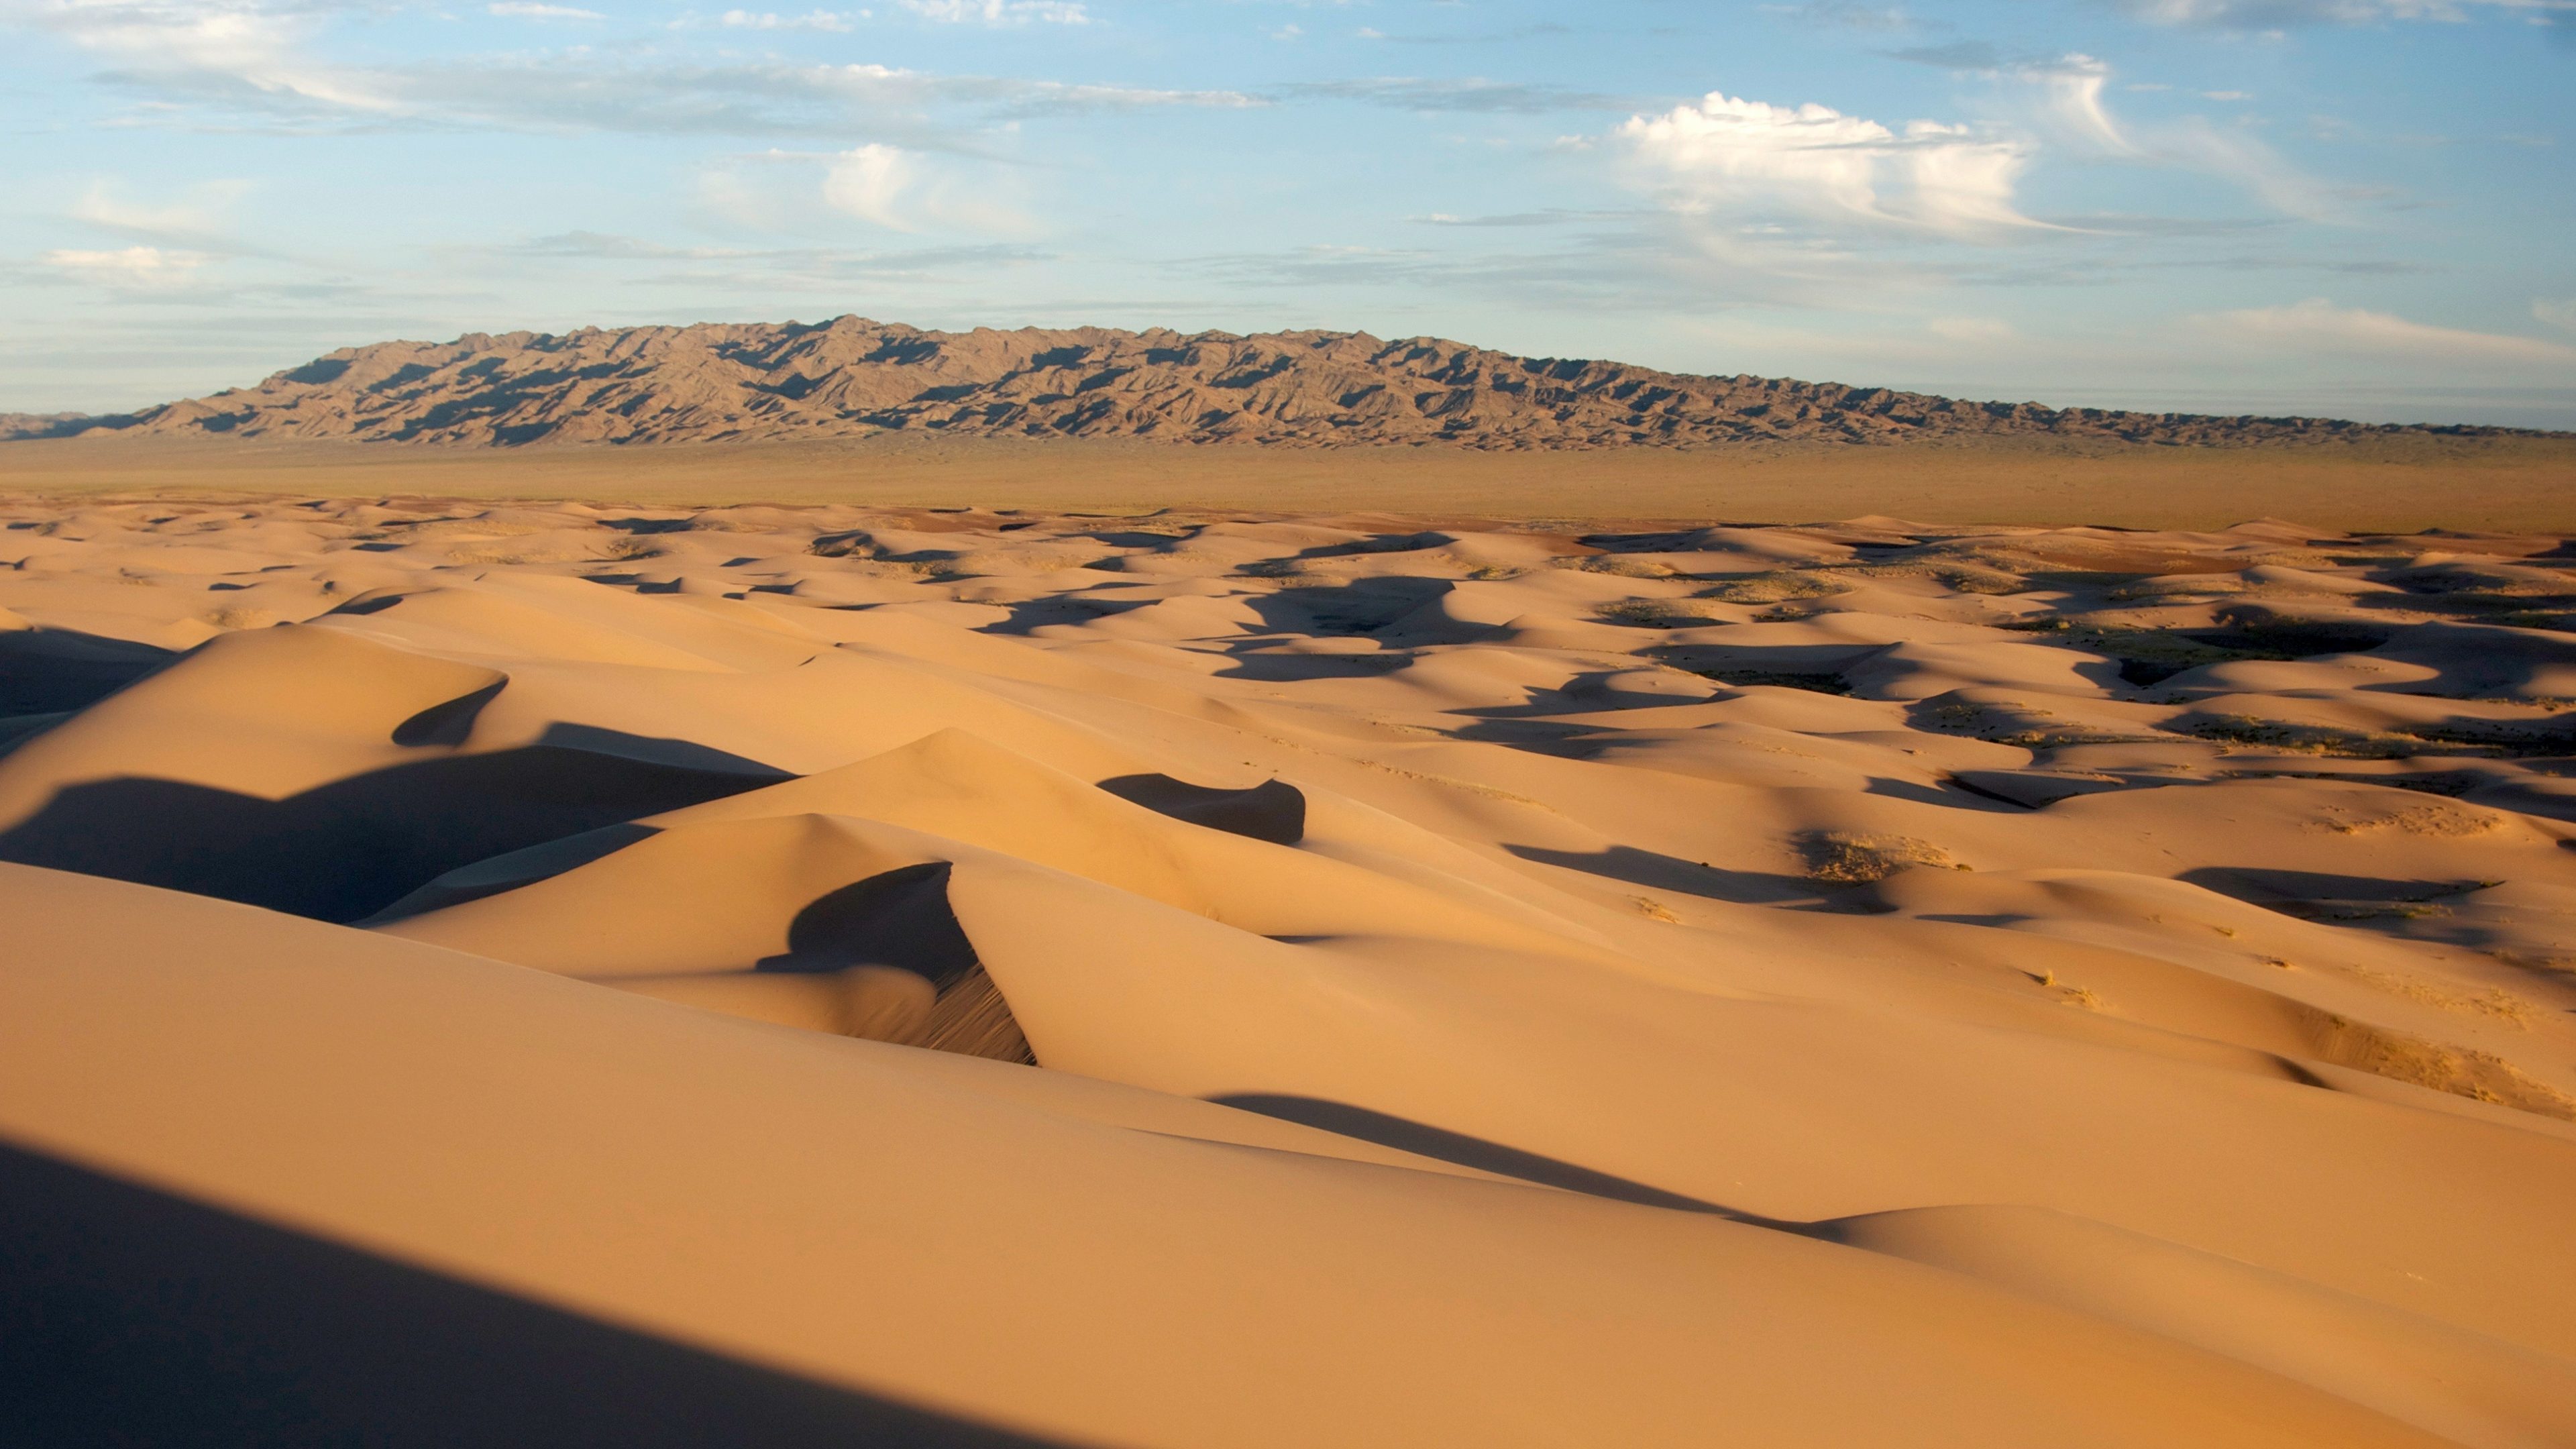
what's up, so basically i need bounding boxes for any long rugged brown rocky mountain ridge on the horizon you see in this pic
[0,317,2499,449]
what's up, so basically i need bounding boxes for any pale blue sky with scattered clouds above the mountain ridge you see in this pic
[0,0,2576,428]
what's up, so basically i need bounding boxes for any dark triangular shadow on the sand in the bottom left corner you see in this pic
[0,1144,1054,1449]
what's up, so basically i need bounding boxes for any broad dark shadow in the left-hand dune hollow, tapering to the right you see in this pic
[0,724,791,923]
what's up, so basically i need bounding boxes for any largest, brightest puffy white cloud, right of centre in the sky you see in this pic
[1615,91,2040,239]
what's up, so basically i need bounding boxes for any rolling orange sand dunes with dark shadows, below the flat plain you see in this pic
[0,498,2576,1449]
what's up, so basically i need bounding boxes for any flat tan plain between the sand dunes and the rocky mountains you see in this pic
[0,436,2576,531]
